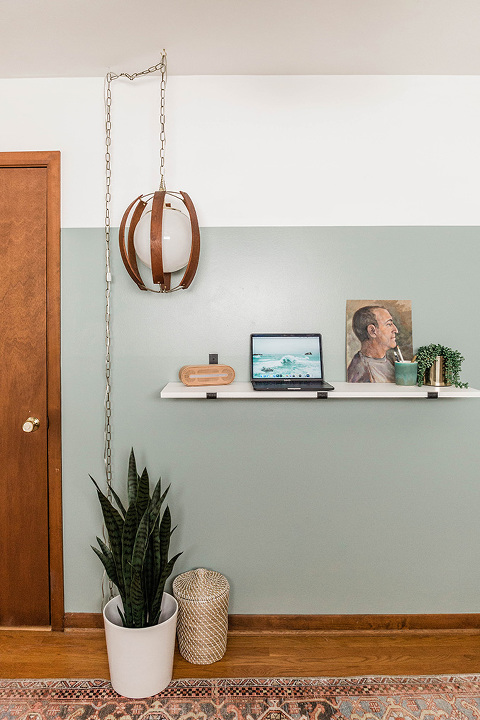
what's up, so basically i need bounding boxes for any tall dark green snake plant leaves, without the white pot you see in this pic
[90,448,181,628]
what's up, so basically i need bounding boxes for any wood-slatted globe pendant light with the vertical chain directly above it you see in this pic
[119,51,200,293]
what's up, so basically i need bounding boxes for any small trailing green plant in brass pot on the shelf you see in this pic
[414,343,468,388]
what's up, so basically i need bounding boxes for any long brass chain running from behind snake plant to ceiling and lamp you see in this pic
[102,50,167,607]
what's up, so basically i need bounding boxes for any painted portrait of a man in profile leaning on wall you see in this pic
[347,300,413,382]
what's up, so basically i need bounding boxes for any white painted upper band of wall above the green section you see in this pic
[0,76,480,227]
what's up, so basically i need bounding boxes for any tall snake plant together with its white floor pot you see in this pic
[90,449,181,698]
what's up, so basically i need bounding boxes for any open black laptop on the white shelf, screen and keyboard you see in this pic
[250,333,334,392]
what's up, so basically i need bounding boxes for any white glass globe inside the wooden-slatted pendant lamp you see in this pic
[133,206,192,273]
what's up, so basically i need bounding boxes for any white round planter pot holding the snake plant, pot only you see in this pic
[103,593,178,698]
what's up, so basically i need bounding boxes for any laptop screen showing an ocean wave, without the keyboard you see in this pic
[251,334,323,380]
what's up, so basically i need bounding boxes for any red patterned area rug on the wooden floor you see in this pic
[0,675,480,720]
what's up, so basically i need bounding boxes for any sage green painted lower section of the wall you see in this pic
[62,227,480,613]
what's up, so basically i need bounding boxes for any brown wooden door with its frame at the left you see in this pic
[0,152,63,629]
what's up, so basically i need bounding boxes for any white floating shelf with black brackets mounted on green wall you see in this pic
[160,380,480,400]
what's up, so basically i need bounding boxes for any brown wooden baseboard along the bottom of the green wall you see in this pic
[65,613,480,634]
